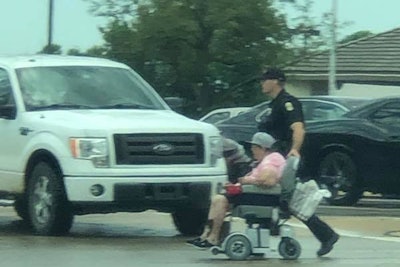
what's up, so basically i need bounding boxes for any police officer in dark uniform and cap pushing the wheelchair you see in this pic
[258,68,339,256]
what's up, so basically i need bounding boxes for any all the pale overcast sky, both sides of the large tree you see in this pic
[0,0,400,54]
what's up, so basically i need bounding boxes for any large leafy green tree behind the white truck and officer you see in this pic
[85,0,290,117]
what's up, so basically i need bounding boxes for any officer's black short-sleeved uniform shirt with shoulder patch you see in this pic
[258,90,304,153]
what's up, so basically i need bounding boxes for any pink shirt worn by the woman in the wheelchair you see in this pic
[247,152,286,183]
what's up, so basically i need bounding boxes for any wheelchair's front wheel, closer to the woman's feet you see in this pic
[225,235,251,260]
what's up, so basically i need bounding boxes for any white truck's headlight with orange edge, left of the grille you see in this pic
[69,138,109,168]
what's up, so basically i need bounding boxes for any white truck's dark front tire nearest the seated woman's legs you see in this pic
[172,208,208,236]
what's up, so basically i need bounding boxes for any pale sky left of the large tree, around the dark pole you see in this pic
[0,0,105,54]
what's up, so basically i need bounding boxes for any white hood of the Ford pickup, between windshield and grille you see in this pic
[24,110,218,134]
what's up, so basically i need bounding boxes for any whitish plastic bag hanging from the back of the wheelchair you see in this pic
[289,180,331,221]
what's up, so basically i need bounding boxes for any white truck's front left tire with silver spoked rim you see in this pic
[27,161,73,235]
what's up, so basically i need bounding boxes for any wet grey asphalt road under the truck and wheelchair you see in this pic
[0,198,400,267]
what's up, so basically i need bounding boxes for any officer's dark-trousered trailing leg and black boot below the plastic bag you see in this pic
[301,214,339,256]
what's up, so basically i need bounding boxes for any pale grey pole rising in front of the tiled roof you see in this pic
[328,0,337,95]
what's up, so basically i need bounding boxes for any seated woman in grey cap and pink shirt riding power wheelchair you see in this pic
[187,132,285,249]
